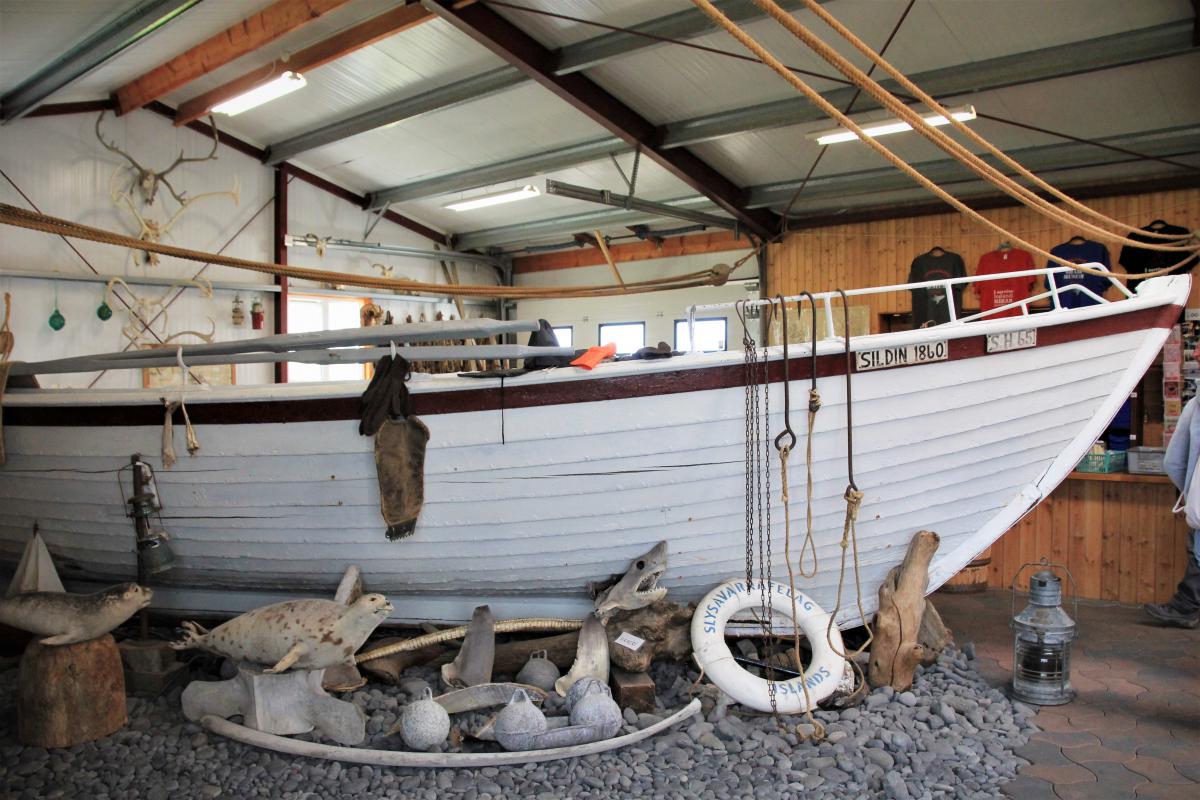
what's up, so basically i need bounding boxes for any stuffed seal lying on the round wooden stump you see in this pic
[0,583,154,645]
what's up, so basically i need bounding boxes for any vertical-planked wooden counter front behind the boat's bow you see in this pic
[988,473,1188,603]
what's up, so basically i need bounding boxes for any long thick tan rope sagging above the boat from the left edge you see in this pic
[0,203,732,300]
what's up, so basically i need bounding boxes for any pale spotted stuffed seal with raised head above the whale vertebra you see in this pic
[170,595,392,673]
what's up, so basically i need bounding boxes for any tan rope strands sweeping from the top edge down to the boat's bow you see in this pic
[692,0,1200,279]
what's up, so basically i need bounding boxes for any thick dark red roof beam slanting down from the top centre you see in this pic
[427,0,779,239]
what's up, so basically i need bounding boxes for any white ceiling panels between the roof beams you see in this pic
[0,0,1200,247]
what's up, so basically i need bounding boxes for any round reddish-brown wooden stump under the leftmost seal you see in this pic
[17,633,127,747]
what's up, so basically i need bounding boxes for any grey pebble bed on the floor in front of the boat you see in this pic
[0,645,1037,800]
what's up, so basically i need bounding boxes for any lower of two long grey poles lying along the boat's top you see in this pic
[12,344,575,375]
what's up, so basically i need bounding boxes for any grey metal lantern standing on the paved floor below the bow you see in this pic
[1010,559,1079,705]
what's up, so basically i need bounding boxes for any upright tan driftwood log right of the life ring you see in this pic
[866,530,940,692]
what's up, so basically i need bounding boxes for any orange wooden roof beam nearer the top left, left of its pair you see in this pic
[115,0,349,116]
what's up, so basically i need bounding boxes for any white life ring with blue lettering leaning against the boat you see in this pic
[691,581,846,714]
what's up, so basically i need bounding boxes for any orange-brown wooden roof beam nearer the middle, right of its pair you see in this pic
[175,2,433,126]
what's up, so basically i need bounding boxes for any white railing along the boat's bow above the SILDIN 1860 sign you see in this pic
[688,261,1133,349]
